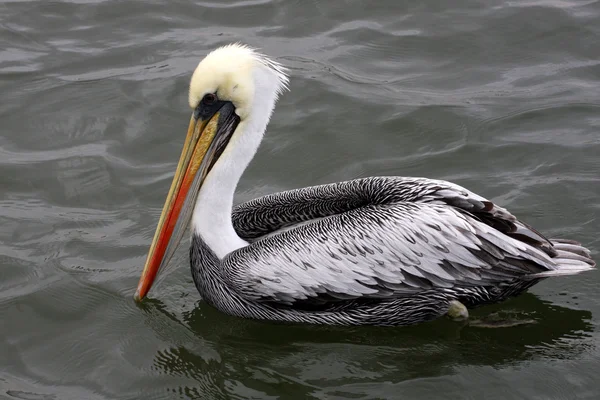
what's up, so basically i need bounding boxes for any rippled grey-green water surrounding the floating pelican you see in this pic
[0,0,600,399]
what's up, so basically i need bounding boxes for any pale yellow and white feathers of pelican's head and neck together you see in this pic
[189,44,288,258]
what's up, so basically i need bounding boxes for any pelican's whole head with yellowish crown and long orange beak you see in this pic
[135,44,288,300]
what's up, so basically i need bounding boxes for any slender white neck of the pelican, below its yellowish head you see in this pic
[192,67,277,259]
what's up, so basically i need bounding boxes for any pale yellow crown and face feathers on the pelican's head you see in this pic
[189,43,289,120]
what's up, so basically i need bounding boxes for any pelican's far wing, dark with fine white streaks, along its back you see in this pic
[232,176,549,247]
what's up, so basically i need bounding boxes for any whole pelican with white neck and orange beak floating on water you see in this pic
[135,44,595,326]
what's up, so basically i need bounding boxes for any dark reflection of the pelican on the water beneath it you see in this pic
[142,293,592,398]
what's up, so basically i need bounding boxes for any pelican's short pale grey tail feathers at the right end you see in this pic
[528,239,596,278]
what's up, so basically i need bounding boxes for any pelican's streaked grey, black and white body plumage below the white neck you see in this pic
[190,177,594,325]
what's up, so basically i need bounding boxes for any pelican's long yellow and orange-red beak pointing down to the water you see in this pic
[134,103,239,301]
